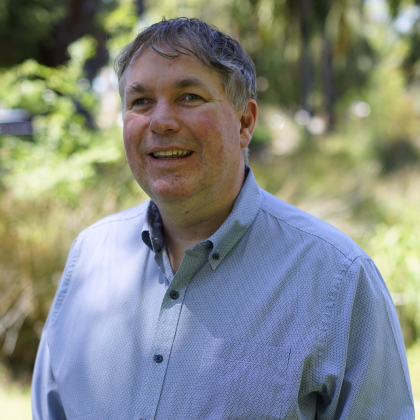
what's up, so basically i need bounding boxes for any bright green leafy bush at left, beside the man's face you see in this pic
[0,37,122,199]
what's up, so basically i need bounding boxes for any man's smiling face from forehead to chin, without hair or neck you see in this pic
[123,50,253,208]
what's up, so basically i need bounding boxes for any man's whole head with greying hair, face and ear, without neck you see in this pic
[116,19,257,213]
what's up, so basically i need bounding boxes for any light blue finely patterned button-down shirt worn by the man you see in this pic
[32,167,414,420]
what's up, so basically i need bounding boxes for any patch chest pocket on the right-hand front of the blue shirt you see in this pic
[191,338,290,420]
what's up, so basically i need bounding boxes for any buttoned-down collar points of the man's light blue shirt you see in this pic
[142,166,261,270]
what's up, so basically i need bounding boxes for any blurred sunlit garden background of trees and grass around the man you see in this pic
[0,0,420,419]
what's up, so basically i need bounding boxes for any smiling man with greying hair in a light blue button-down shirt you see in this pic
[32,19,414,420]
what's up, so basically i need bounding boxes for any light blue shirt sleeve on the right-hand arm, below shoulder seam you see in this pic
[317,258,414,420]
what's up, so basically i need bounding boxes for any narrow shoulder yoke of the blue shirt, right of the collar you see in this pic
[260,189,369,261]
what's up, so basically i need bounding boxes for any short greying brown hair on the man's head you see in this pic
[114,17,257,164]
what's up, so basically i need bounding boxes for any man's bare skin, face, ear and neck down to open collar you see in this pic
[121,48,257,271]
